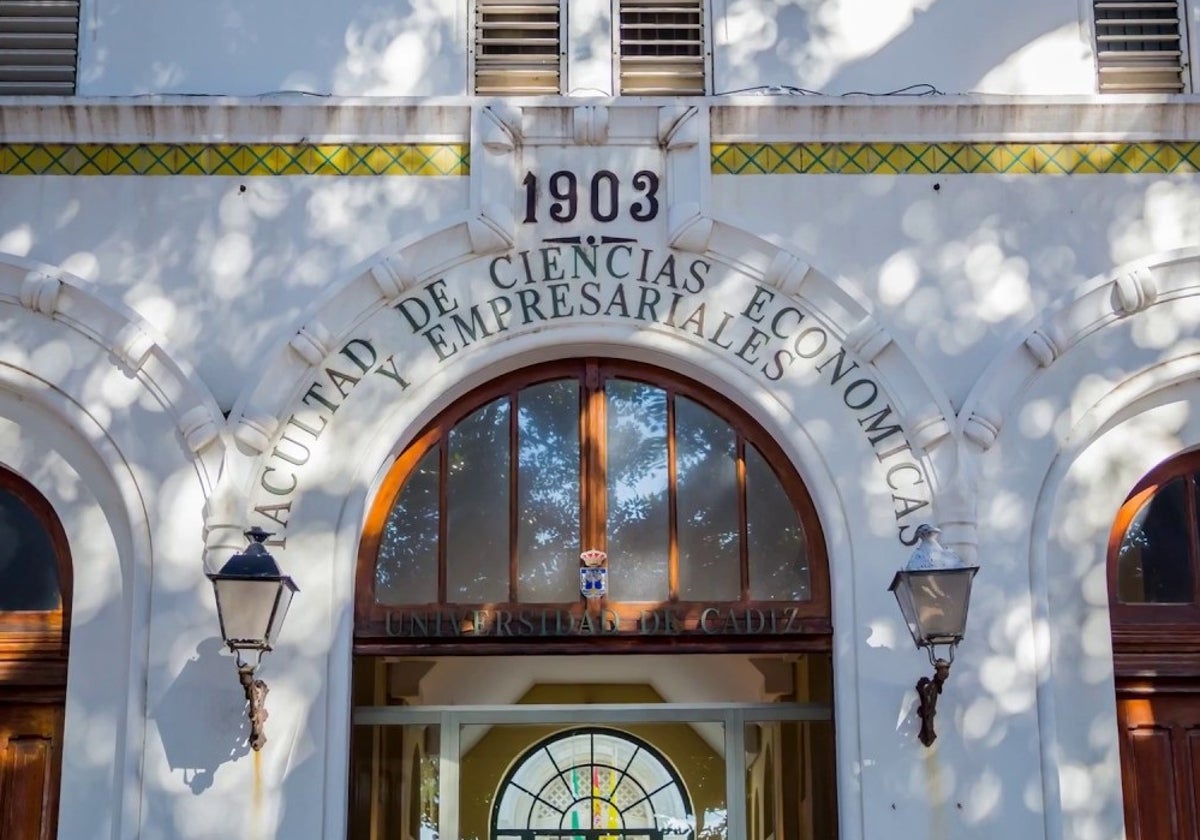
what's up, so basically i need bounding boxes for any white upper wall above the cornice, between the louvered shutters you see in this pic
[78,0,1096,96]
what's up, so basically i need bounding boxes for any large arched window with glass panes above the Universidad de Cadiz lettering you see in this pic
[358,359,829,640]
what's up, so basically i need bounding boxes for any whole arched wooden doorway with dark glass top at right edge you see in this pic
[1109,452,1200,840]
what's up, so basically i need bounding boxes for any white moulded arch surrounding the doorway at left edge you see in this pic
[0,254,223,838]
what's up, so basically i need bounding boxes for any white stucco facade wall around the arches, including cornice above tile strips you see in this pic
[0,101,1200,840]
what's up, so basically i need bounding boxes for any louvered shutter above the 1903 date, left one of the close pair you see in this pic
[475,0,562,95]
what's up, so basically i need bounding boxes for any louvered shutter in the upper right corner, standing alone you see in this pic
[1093,0,1183,94]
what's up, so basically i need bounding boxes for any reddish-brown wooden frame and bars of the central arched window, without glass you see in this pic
[355,358,832,653]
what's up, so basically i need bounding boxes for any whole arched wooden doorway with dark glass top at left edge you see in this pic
[0,470,71,840]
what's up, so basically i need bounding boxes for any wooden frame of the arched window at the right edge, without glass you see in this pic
[1106,450,1200,678]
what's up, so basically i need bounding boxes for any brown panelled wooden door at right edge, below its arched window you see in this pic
[1117,689,1200,840]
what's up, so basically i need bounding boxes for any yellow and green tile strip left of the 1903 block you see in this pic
[0,143,470,176]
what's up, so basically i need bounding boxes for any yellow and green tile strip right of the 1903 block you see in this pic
[712,140,1200,175]
